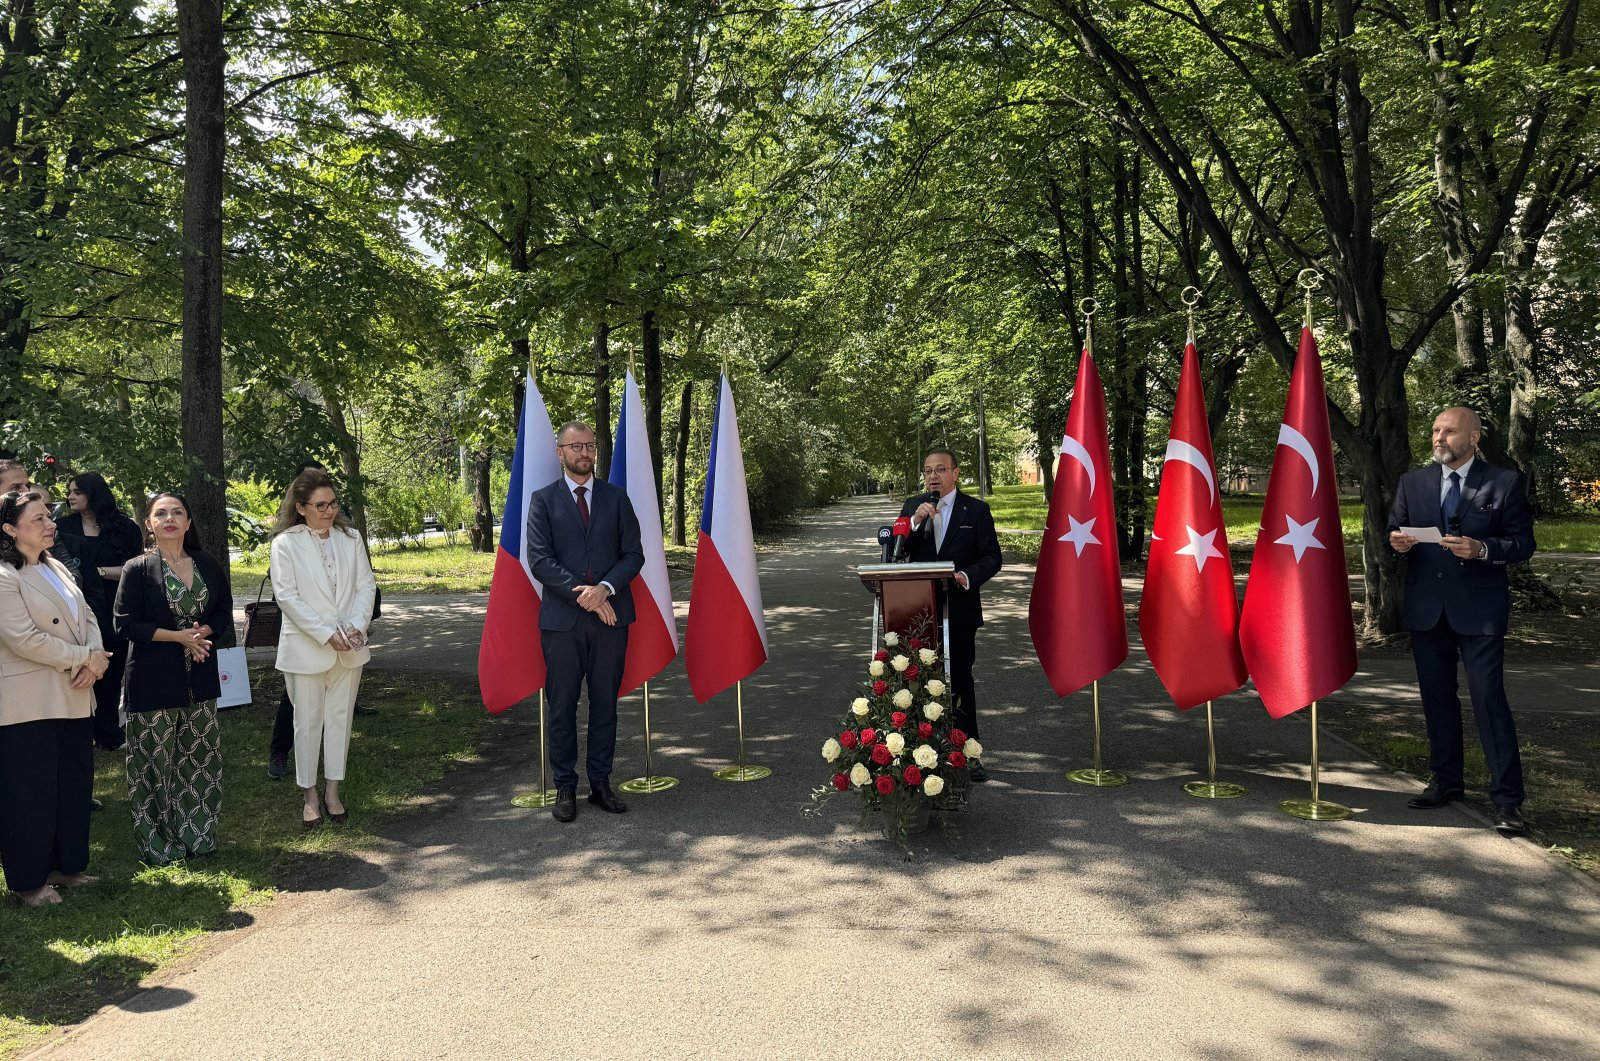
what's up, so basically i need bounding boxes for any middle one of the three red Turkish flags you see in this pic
[1139,338,1245,707]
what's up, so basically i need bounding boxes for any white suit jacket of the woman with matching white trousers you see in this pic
[270,523,378,674]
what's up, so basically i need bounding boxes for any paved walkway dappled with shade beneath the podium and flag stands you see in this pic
[34,501,1600,1061]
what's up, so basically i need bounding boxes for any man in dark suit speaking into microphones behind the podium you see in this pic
[901,450,1000,781]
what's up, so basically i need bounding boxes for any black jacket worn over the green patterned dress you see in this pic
[115,552,234,712]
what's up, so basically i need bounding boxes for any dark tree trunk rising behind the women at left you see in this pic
[178,0,229,571]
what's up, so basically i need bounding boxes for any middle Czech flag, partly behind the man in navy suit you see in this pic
[611,373,678,696]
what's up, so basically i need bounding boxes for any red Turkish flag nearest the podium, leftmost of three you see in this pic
[1027,349,1128,696]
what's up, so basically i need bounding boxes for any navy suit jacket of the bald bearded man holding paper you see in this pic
[1389,456,1534,634]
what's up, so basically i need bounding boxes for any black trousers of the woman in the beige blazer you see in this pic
[0,719,94,891]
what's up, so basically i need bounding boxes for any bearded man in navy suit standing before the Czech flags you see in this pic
[528,421,645,821]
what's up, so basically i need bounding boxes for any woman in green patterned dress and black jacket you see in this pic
[114,493,234,866]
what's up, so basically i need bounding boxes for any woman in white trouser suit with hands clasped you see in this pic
[272,469,376,829]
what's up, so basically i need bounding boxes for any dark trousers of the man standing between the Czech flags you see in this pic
[539,611,627,789]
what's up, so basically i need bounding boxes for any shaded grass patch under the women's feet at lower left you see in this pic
[0,667,485,1058]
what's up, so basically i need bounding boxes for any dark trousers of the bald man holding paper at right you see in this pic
[1411,616,1523,807]
